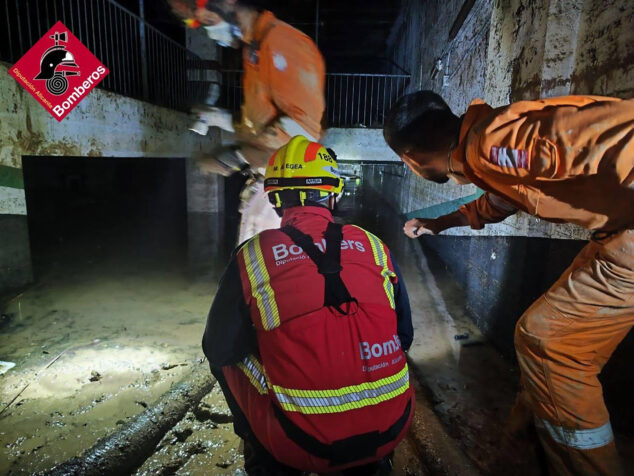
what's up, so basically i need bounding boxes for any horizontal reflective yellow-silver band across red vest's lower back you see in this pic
[273,364,409,414]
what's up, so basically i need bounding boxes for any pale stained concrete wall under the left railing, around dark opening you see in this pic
[0,63,221,294]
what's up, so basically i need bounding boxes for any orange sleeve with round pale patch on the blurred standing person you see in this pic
[262,27,326,138]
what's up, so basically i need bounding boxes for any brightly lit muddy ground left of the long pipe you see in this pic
[0,251,216,474]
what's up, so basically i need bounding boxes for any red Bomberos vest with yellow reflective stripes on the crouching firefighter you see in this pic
[237,215,413,468]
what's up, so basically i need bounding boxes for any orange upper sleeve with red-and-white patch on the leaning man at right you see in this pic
[466,96,619,187]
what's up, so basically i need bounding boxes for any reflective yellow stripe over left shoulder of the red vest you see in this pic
[240,235,280,331]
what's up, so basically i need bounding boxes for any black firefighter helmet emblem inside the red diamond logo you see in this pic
[35,32,79,96]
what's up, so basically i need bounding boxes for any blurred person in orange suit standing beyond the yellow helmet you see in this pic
[170,0,326,242]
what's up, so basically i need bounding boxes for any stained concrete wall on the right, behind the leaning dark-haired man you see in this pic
[380,0,634,355]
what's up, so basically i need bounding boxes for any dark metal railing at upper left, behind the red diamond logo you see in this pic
[0,0,213,111]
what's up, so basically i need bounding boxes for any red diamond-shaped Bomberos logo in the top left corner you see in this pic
[9,22,109,121]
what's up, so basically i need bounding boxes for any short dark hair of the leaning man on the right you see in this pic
[383,91,460,155]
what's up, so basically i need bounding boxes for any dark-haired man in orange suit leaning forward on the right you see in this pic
[384,91,634,475]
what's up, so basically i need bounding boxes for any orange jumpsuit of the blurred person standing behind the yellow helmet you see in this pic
[236,11,326,242]
